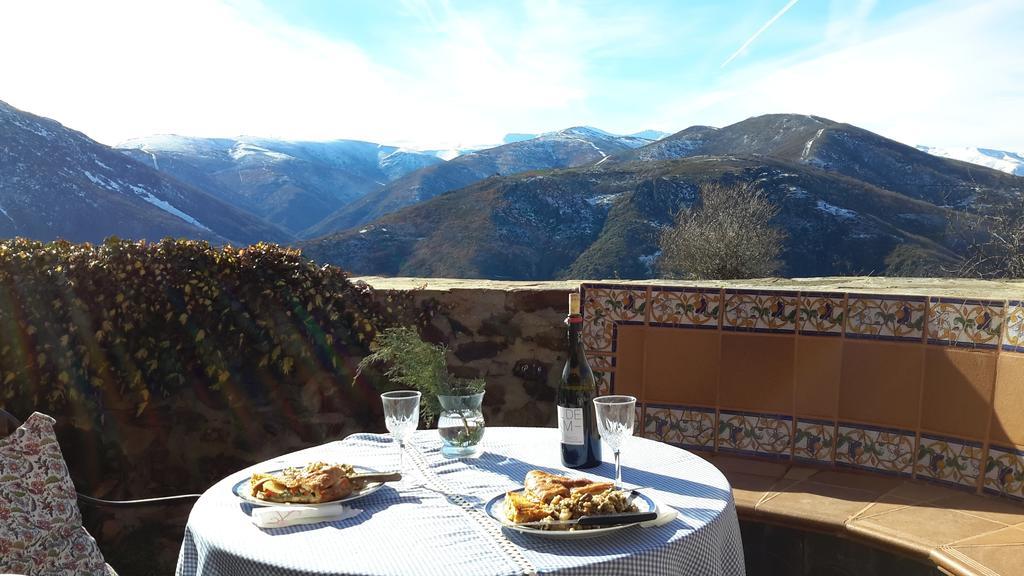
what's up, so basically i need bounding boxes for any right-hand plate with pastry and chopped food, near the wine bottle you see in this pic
[485,470,657,538]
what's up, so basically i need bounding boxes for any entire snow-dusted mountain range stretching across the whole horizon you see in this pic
[0,102,1024,279]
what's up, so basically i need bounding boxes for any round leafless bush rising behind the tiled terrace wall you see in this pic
[658,181,785,280]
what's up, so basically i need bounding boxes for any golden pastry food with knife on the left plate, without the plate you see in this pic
[249,462,401,504]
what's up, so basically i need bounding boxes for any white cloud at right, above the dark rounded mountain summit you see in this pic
[658,0,1024,150]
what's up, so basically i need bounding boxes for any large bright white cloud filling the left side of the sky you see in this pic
[0,0,655,146]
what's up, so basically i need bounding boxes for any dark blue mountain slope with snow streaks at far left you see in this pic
[0,101,291,244]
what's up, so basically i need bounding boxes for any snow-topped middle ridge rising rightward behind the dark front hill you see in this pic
[306,127,650,236]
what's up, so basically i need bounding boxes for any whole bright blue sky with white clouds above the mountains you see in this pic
[0,0,1024,151]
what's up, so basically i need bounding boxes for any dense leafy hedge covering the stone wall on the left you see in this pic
[0,238,416,419]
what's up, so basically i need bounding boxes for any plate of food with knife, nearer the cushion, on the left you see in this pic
[231,462,401,507]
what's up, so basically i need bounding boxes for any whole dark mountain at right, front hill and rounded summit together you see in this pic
[301,115,1024,280]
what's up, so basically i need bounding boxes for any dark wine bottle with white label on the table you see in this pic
[556,292,601,468]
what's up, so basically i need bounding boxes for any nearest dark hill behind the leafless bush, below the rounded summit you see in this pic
[301,145,1011,280]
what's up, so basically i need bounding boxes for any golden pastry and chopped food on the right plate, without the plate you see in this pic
[505,470,638,530]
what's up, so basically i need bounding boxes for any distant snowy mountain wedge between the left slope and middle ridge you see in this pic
[119,135,443,234]
